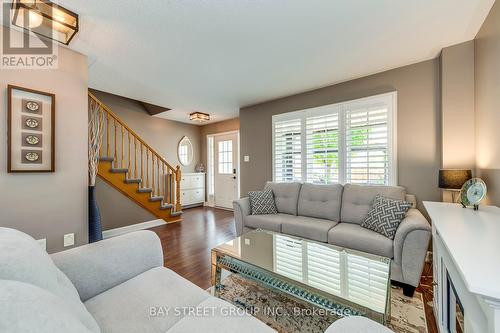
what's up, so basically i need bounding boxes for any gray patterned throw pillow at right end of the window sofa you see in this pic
[361,194,411,239]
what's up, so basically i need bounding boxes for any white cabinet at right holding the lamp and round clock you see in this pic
[424,202,500,333]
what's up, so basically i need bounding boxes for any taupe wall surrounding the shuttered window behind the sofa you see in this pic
[240,59,441,208]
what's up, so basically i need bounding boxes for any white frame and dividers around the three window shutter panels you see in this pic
[271,91,398,186]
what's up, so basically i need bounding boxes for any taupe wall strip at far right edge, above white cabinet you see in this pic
[475,1,500,206]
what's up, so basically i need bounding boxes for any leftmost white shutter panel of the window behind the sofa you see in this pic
[274,119,302,182]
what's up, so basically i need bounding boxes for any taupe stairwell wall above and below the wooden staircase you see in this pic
[91,90,202,230]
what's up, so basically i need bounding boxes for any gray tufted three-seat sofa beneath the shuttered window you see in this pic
[233,182,431,296]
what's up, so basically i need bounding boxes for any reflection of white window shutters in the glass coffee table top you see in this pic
[273,234,390,313]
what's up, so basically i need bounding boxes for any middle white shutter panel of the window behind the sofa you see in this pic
[306,110,340,184]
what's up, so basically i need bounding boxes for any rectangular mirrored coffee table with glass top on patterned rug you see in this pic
[212,230,391,324]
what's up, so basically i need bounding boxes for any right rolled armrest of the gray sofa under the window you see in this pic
[394,208,431,287]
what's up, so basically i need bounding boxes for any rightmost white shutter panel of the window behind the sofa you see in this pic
[345,104,391,185]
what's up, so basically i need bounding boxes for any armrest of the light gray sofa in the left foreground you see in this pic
[51,230,163,301]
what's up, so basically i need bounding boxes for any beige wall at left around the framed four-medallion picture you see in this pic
[0,26,88,252]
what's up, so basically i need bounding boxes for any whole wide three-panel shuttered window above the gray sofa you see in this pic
[273,92,397,185]
